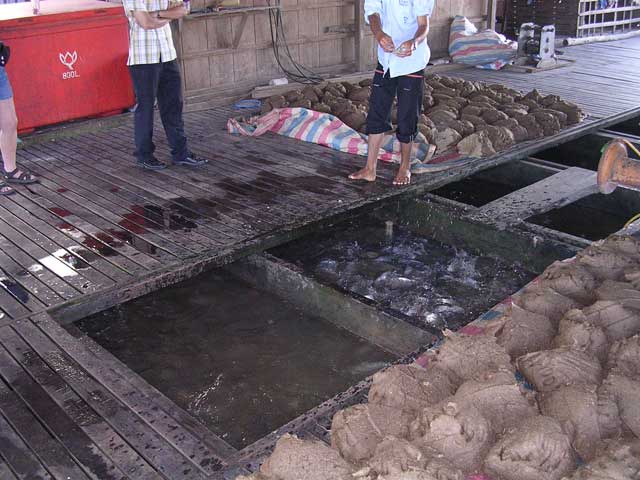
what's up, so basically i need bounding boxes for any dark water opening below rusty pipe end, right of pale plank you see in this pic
[527,198,632,241]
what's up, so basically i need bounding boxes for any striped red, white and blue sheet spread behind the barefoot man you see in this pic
[227,108,468,173]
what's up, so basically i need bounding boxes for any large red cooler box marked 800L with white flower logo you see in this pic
[0,0,134,131]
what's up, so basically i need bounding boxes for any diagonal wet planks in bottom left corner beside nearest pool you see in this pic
[0,314,235,480]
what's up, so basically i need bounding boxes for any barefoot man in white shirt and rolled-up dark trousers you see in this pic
[349,0,434,185]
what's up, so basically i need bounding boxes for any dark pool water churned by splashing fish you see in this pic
[272,219,535,329]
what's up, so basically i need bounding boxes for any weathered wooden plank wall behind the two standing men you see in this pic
[176,0,488,106]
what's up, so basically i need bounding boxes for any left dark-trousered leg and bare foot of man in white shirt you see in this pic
[349,64,396,182]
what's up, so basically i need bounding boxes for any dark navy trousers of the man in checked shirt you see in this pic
[129,60,189,162]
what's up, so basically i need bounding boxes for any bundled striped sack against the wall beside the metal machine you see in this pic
[449,15,518,70]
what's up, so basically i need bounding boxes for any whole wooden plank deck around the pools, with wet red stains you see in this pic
[0,39,640,479]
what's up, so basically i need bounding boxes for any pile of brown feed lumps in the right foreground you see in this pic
[238,236,640,480]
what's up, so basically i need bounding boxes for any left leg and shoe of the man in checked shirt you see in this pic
[129,63,165,170]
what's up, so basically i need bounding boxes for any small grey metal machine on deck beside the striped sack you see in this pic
[515,23,558,69]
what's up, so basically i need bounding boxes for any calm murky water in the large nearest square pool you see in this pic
[76,272,393,448]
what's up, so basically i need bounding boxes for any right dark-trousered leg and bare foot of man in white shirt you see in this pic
[393,72,424,185]
